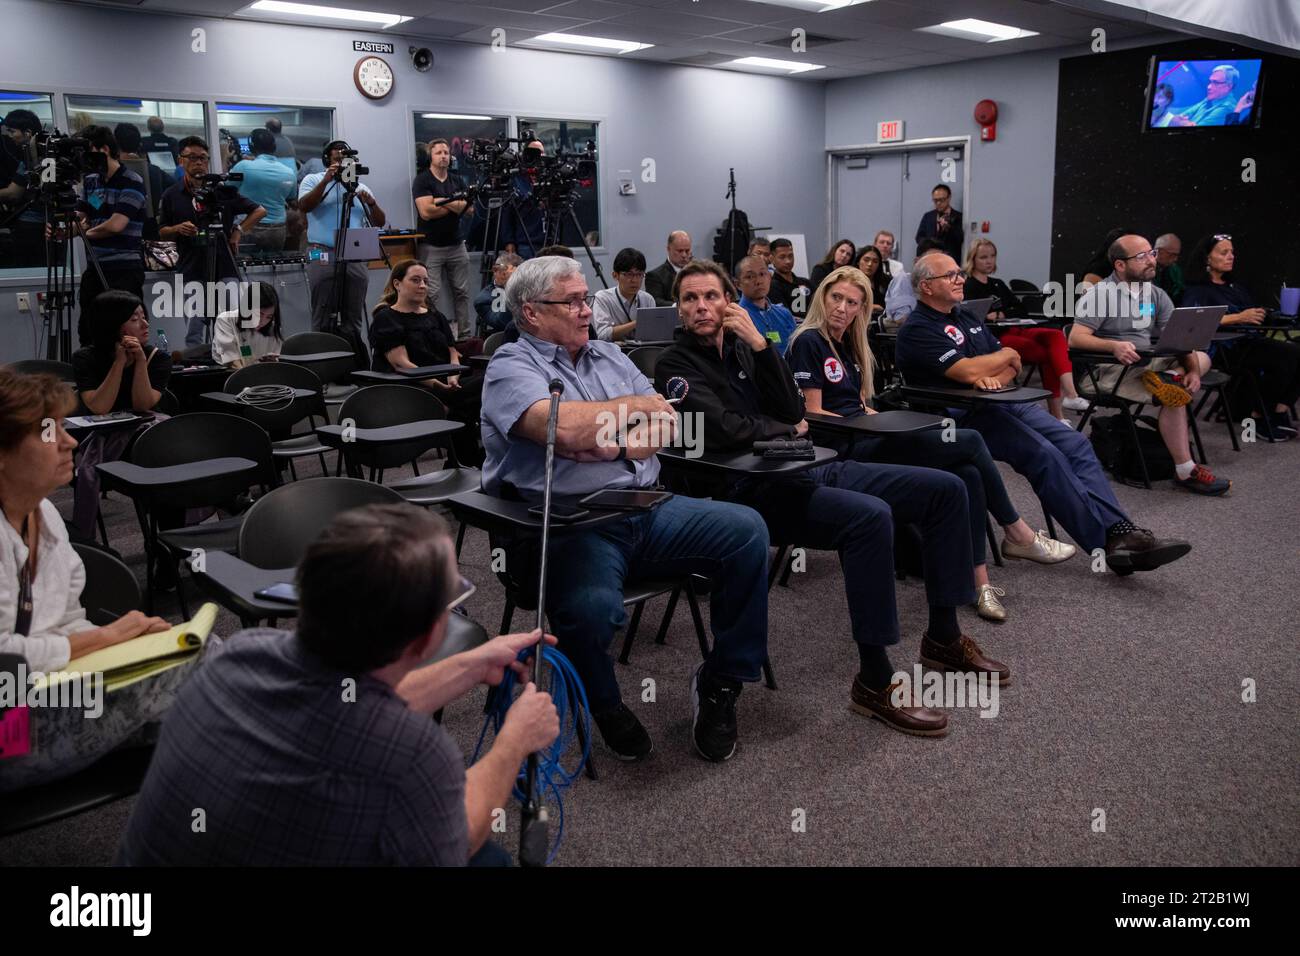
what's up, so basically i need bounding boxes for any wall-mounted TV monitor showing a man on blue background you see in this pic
[1143,57,1264,130]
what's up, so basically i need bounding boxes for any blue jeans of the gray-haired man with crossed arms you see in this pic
[546,496,768,713]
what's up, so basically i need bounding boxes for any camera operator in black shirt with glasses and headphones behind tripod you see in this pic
[159,137,267,347]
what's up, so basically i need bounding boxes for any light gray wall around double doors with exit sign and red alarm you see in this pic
[826,51,1079,282]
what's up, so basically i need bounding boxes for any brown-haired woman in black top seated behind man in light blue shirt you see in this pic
[371,259,482,464]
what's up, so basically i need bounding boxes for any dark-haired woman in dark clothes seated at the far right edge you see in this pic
[1183,233,1300,441]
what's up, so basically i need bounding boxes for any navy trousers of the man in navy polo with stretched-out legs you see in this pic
[957,405,1128,551]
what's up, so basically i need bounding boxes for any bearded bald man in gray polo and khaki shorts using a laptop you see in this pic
[1070,235,1232,496]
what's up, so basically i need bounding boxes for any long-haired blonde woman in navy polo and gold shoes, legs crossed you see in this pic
[785,267,1075,620]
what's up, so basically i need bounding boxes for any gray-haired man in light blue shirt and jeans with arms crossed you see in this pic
[482,256,768,761]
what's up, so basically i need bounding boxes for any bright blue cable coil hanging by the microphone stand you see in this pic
[469,645,592,864]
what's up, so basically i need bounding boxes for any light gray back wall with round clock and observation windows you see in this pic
[0,0,827,360]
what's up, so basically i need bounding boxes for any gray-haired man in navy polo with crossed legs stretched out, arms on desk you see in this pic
[896,252,1192,575]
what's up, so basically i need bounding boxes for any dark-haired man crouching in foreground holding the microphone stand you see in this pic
[117,505,559,866]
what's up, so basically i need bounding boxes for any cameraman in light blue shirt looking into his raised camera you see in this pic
[298,139,387,358]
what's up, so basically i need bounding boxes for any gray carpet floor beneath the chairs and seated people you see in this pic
[0,411,1300,865]
